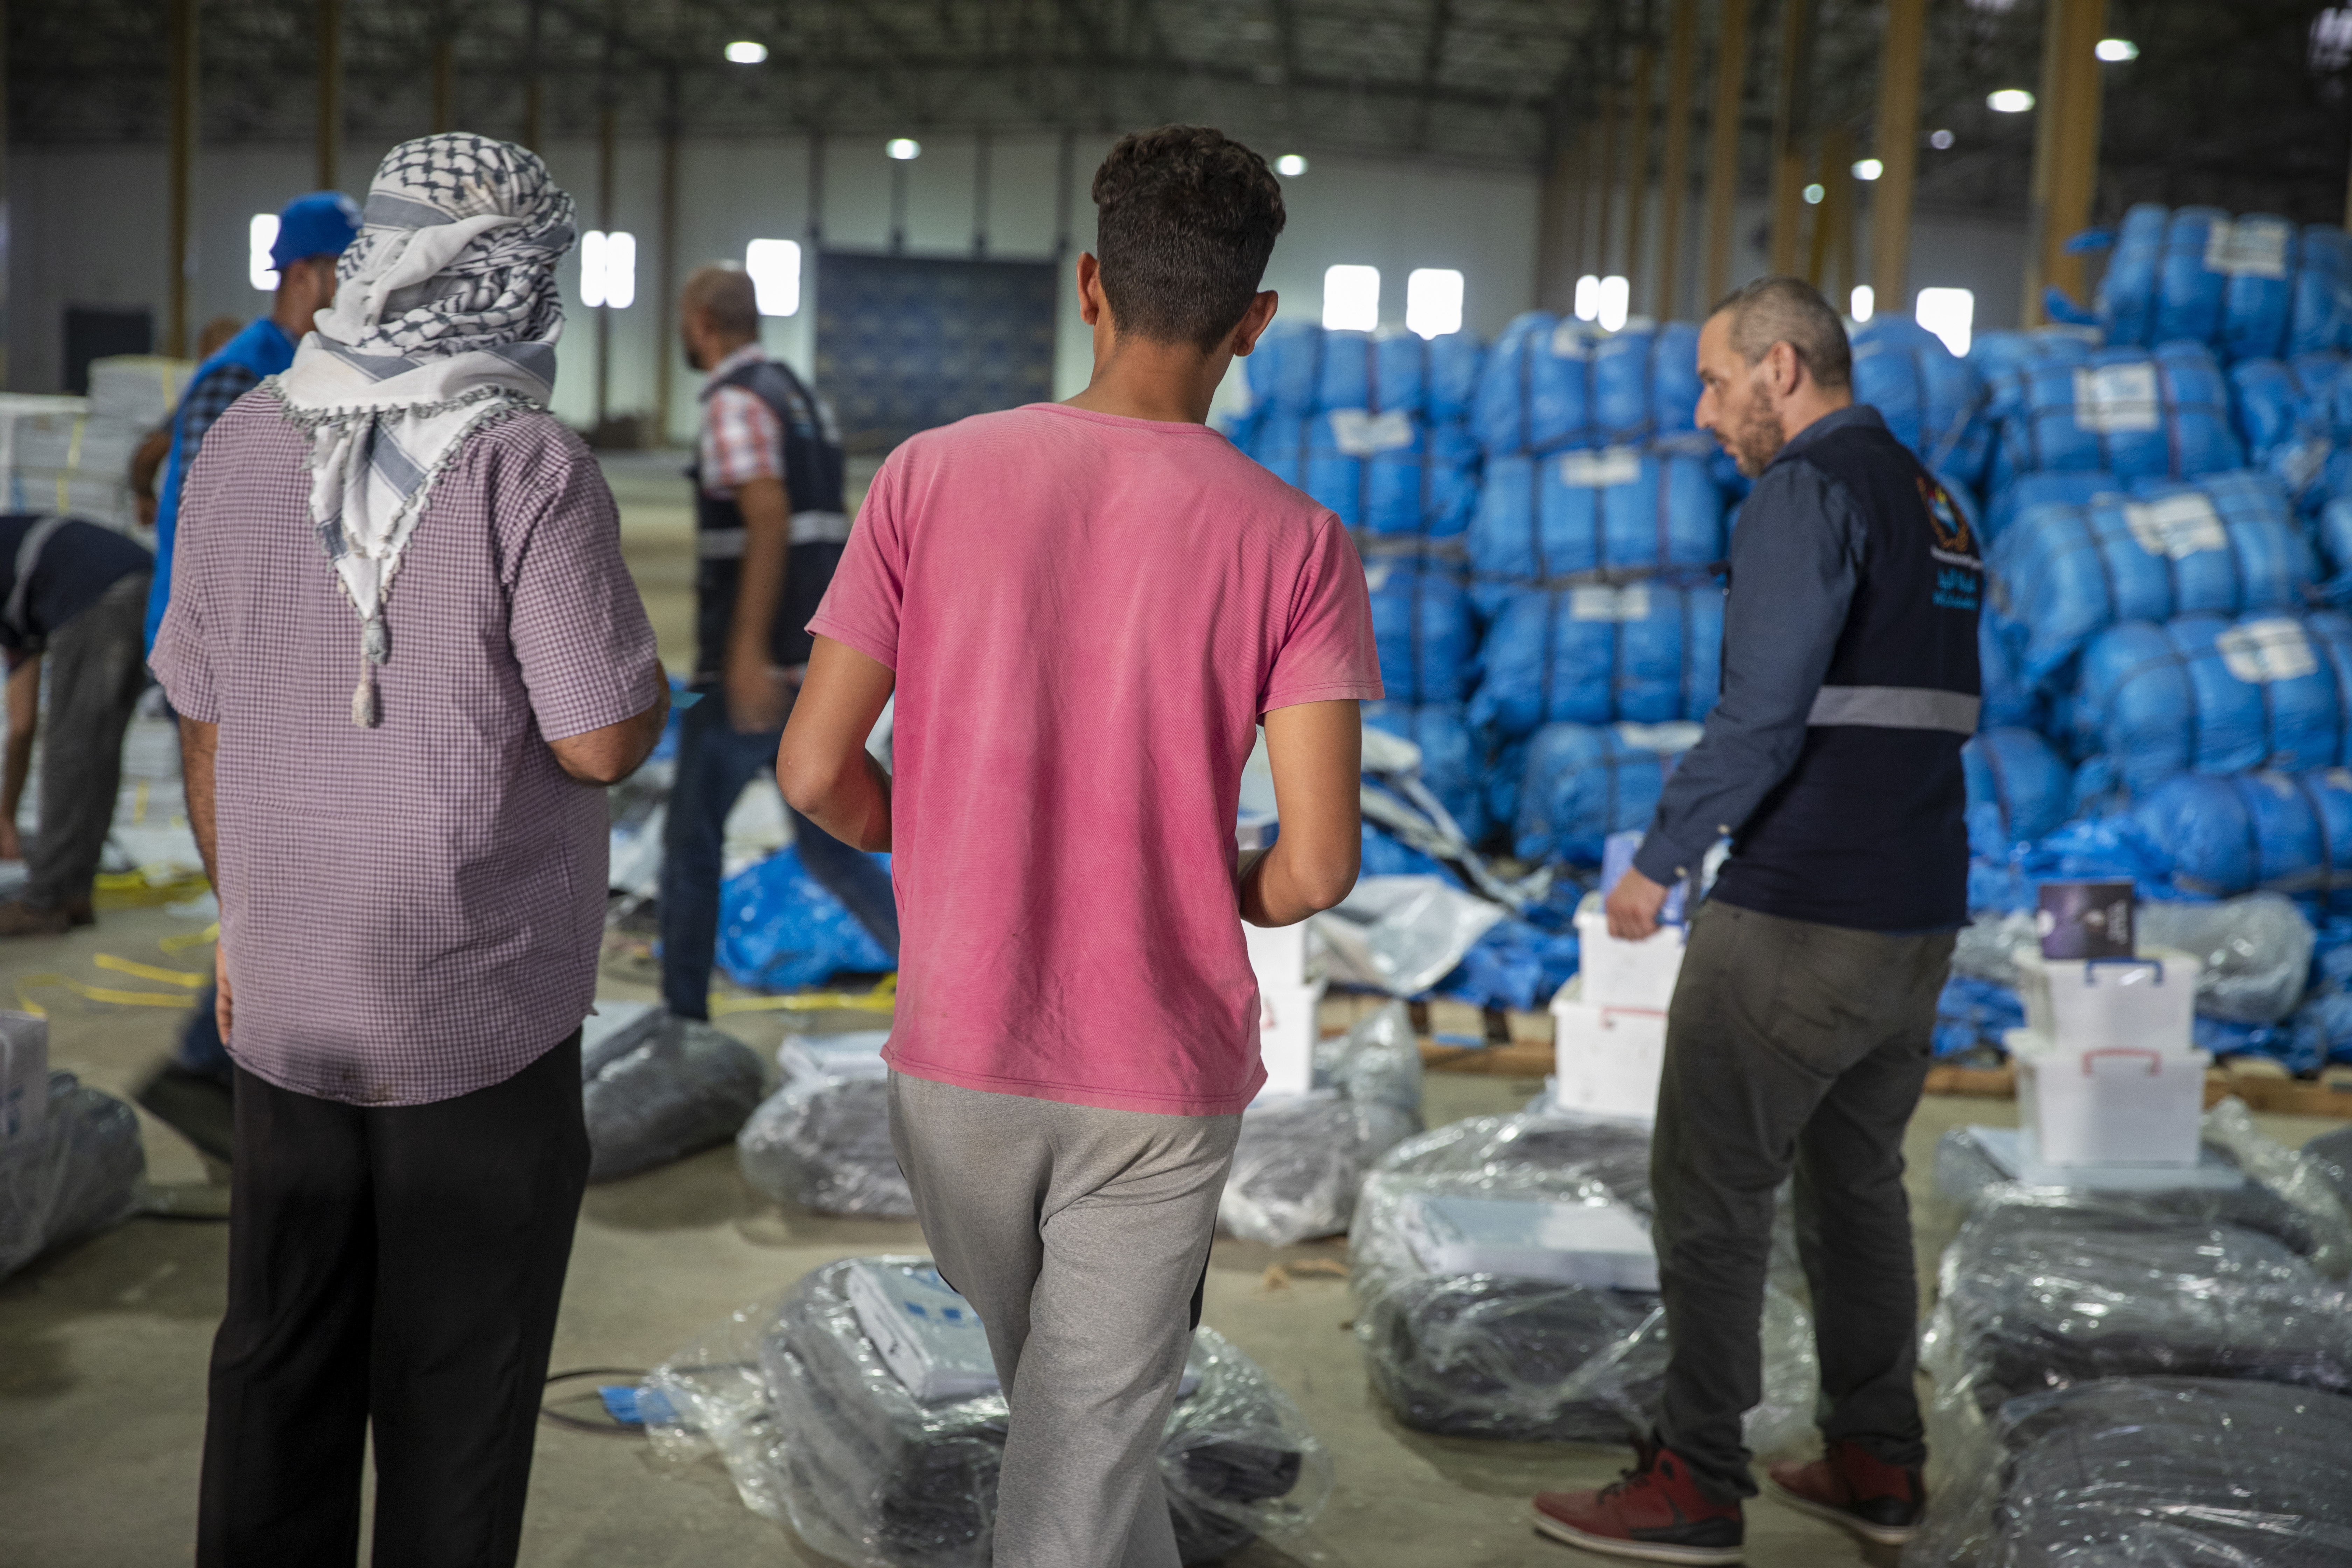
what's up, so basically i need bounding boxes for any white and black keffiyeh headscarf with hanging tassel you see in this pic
[271,132,574,726]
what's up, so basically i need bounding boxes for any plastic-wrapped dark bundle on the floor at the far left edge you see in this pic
[0,1072,146,1279]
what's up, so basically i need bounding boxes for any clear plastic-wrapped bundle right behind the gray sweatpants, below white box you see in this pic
[1216,1001,1421,1246]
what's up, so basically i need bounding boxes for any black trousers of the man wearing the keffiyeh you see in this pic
[195,1032,588,1568]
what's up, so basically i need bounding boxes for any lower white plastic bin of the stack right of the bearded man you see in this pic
[2006,1030,2213,1168]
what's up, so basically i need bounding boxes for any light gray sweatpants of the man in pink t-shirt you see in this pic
[889,1072,1242,1568]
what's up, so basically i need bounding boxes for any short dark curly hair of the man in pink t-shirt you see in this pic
[1094,125,1284,352]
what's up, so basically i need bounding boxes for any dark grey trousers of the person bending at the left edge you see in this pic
[23,571,148,910]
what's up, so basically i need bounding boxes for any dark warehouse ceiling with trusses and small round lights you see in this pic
[7,0,2352,219]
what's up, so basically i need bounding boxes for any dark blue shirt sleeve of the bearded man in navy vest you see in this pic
[1632,461,1865,882]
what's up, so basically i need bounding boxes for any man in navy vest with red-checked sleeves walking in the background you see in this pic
[659,266,898,1018]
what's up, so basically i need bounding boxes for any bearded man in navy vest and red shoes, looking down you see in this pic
[1536,278,1985,1563]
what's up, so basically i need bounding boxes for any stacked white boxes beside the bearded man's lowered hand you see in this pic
[1552,896,1684,1121]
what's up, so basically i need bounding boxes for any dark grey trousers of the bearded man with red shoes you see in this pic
[1651,900,1954,1500]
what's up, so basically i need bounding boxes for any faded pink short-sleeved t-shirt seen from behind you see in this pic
[809,404,1381,1116]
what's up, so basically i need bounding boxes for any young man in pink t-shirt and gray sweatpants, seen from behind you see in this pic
[776,127,1381,1568]
